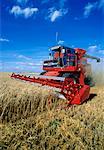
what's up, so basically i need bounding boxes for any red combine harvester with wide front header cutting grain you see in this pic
[11,45,100,105]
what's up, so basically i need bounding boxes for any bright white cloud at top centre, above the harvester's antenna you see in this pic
[48,8,68,22]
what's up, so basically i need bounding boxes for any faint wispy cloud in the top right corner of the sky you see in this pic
[84,2,98,18]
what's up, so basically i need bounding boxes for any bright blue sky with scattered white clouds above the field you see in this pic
[0,0,104,72]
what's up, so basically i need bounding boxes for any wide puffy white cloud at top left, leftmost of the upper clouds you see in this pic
[10,6,38,18]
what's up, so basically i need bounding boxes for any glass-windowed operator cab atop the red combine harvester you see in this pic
[43,45,77,68]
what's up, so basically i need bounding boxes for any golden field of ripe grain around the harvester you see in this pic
[0,73,104,150]
